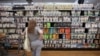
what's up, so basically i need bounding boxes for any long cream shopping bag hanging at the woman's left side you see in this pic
[23,28,31,52]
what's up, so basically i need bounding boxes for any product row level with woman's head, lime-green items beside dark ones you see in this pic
[0,22,100,29]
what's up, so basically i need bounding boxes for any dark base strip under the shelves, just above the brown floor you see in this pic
[8,47,100,51]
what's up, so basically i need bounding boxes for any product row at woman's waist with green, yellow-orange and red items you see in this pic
[44,33,100,40]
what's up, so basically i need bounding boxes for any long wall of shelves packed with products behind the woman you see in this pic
[0,3,100,50]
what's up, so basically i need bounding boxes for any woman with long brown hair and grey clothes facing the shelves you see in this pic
[24,20,43,56]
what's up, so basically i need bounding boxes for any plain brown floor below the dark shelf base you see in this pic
[9,50,100,56]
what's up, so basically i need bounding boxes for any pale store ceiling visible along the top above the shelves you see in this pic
[0,0,100,4]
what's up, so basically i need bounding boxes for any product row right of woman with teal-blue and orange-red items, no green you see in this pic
[43,28,99,34]
